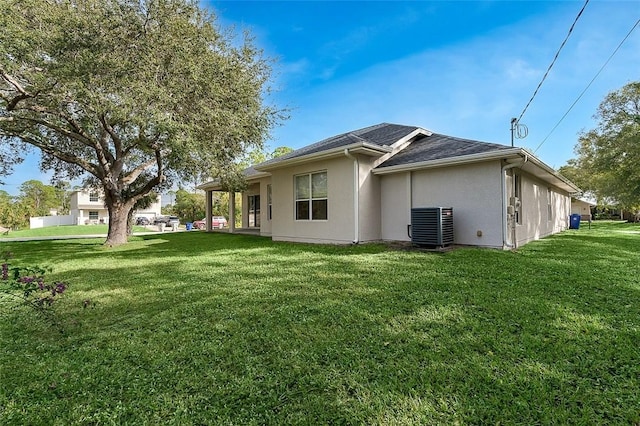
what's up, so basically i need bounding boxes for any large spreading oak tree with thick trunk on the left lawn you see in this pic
[0,0,281,245]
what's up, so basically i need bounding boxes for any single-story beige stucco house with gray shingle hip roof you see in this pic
[198,123,579,248]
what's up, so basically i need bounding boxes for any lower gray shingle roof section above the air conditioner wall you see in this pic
[377,133,512,169]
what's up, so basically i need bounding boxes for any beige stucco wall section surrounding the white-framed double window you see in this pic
[263,157,355,244]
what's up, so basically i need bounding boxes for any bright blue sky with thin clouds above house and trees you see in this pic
[0,0,640,193]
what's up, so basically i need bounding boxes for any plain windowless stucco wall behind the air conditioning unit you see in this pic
[382,161,502,247]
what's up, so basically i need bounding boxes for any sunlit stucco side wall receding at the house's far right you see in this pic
[516,173,571,246]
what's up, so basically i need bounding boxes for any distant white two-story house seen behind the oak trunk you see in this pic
[69,189,161,225]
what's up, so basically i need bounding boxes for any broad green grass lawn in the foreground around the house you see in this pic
[0,223,640,425]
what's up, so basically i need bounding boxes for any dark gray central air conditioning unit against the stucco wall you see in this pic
[411,207,453,247]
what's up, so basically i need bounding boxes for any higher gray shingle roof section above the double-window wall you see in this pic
[260,123,419,165]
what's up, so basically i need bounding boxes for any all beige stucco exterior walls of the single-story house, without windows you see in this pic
[260,156,571,248]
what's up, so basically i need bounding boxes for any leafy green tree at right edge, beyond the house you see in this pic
[562,82,640,208]
